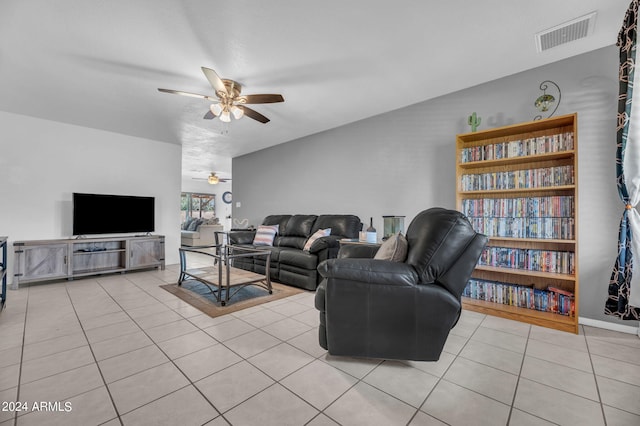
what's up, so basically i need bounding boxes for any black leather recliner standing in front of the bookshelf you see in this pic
[315,208,488,361]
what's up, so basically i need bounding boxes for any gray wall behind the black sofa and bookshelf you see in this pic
[233,46,637,326]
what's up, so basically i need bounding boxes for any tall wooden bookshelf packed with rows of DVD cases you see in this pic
[456,114,579,333]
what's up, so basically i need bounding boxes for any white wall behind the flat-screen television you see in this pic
[0,112,181,282]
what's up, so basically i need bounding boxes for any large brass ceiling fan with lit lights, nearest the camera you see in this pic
[158,67,284,123]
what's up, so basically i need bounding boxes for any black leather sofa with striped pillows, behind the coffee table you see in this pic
[229,214,362,290]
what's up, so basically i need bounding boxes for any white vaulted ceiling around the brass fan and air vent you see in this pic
[0,0,630,177]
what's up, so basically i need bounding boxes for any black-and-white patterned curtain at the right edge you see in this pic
[604,0,640,320]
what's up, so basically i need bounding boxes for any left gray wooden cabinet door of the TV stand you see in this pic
[15,244,69,282]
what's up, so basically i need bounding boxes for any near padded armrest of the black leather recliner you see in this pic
[318,258,418,286]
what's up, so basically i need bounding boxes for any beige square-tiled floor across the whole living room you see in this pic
[0,266,640,426]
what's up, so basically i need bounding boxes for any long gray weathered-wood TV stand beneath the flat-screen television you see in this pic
[11,235,165,289]
